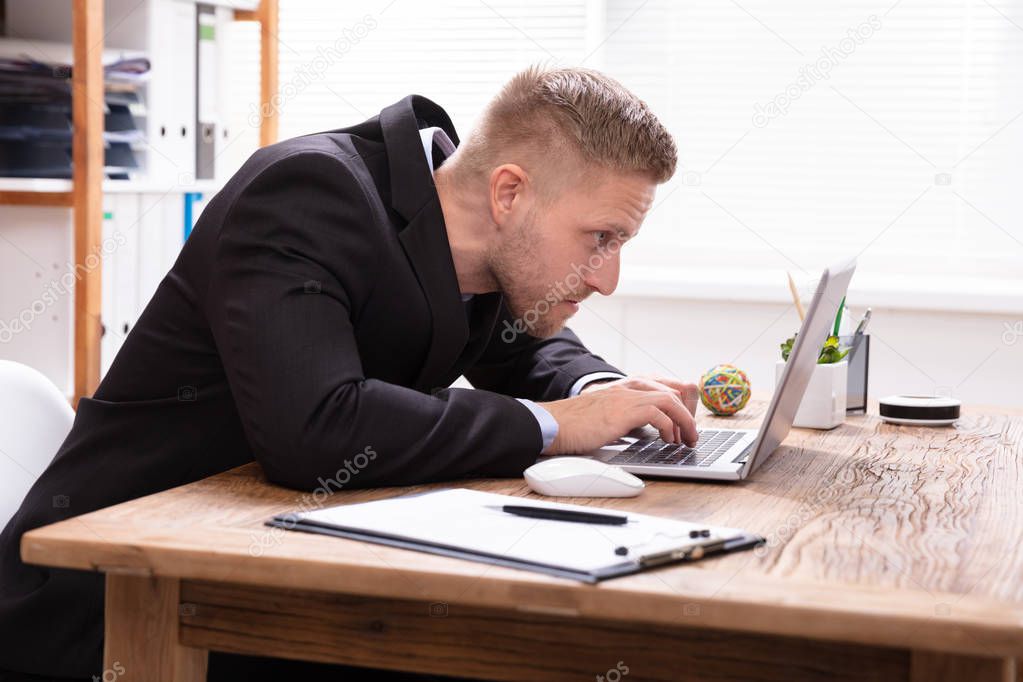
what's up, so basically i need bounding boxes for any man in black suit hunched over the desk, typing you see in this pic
[0,69,697,679]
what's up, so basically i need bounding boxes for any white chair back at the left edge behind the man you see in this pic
[0,360,75,530]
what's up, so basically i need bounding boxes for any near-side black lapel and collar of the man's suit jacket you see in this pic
[381,95,469,392]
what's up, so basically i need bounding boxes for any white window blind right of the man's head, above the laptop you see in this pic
[604,0,1023,282]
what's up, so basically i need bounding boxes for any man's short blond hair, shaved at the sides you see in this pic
[451,66,677,189]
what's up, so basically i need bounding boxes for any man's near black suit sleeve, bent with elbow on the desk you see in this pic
[206,148,542,490]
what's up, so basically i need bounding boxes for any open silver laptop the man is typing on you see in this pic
[568,260,856,481]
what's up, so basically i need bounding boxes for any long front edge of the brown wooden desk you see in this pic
[21,527,1023,657]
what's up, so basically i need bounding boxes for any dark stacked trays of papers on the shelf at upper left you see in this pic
[0,57,149,179]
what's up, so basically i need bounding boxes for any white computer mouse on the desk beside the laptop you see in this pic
[523,457,644,497]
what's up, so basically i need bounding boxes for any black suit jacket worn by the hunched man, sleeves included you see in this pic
[0,96,617,676]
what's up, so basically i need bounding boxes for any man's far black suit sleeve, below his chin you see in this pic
[465,307,625,401]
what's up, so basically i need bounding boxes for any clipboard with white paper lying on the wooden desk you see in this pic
[267,488,764,583]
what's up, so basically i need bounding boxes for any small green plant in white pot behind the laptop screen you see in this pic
[774,335,849,428]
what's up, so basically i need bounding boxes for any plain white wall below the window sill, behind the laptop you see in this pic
[570,294,1023,407]
